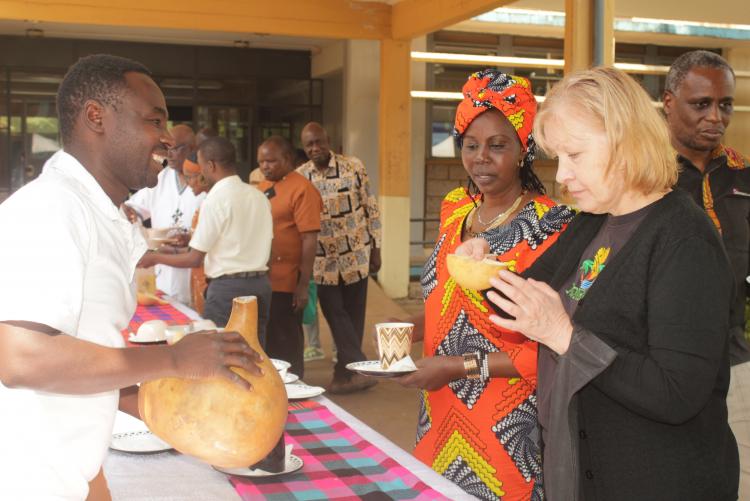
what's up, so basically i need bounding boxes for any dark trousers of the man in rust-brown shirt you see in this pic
[266,292,305,378]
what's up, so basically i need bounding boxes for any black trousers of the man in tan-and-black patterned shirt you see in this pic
[318,278,367,379]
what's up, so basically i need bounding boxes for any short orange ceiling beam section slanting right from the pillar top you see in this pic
[391,0,513,40]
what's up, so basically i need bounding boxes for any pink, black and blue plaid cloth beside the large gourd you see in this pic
[231,402,447,501]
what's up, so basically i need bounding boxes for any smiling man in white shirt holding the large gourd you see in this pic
[0,55,260,501]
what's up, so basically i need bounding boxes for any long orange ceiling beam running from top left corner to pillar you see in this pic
[0,0,391,39]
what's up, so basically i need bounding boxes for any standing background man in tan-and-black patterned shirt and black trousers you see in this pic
[297,122,380,393]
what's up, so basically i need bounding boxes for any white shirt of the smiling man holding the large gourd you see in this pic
[0,151,146,500]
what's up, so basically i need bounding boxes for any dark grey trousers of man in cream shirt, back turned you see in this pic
[203,275,271,347]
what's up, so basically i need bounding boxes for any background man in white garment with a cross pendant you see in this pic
[125,124,206,304]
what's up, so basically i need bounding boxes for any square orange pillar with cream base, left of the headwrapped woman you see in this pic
[378,39,412,297]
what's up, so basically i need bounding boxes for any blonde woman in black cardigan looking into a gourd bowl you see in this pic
[460,68,738,501]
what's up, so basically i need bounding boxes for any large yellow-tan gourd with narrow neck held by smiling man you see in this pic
[138,296,288,468]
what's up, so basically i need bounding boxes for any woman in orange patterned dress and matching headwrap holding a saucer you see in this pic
[399,70,573,501]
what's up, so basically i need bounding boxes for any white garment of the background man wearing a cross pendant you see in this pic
[128,167,206,304]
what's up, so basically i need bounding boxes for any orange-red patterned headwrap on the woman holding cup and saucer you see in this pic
[453,70,536,150]
